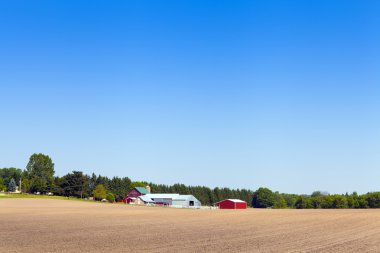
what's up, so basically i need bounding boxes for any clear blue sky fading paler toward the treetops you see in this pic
[0,0,380,193]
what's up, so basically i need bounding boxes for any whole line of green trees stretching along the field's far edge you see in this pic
[0,154,380,209]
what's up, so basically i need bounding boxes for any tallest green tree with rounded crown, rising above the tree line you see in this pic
[26,153,54,192]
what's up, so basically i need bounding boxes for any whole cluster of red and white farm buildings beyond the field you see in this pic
[123,186,247,209]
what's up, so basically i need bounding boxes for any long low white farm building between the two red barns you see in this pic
[135,193,201,208]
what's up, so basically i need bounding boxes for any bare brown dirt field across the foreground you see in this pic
[0,199,380,253]
